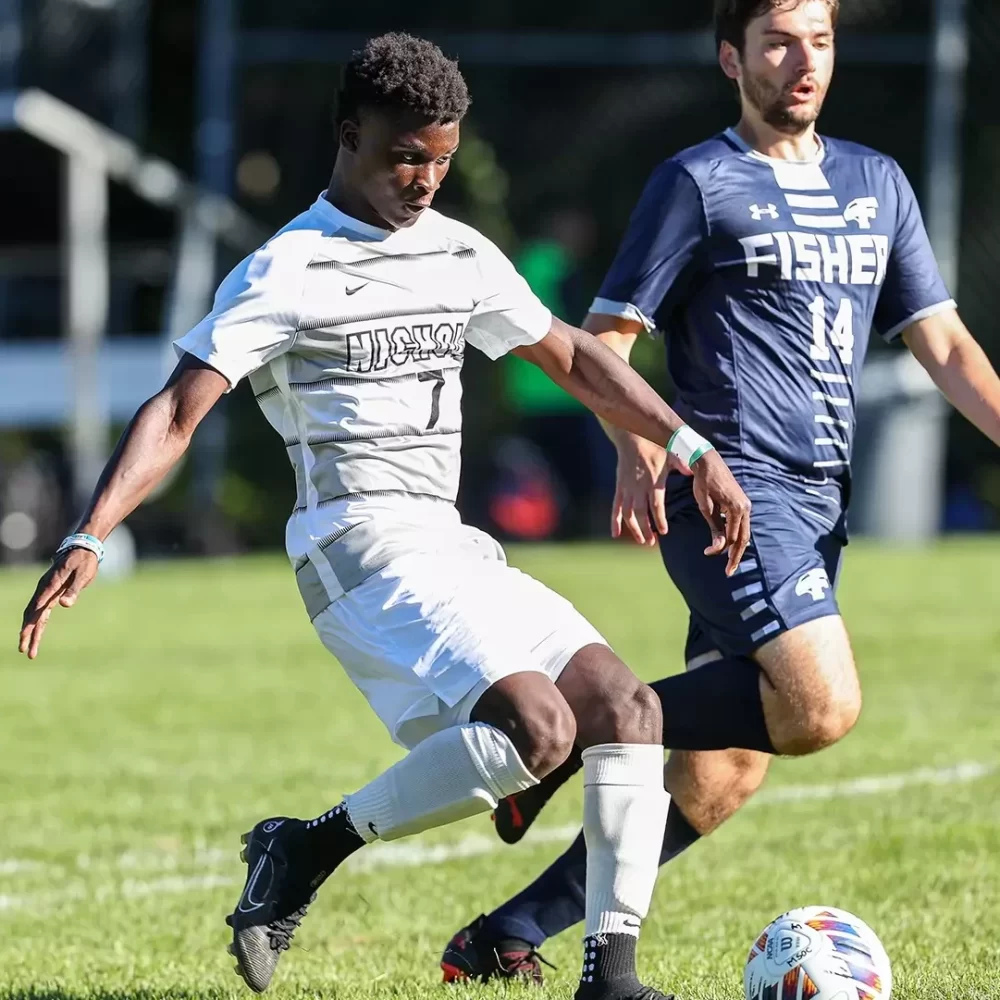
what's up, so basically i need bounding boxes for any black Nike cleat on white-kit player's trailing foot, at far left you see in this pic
[226,816,329,993]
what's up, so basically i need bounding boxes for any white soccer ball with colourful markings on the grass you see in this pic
[743,906,892,1000]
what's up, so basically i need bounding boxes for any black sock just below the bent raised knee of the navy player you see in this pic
[650,657,777,753]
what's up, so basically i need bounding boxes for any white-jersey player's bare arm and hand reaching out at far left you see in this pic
[18,354,229,659]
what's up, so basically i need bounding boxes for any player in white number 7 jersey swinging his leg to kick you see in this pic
[21,34,749,1000]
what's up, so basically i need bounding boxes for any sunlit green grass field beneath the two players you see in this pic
[0,540,1000,1000]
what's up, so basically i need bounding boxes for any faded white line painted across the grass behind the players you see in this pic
[0,761,998,913]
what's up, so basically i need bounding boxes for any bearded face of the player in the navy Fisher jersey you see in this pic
[740,0,834,133]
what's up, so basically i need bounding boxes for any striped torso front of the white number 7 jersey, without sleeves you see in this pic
[251,238,476,509]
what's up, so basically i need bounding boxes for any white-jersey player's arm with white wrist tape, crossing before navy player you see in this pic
[515,319,750,574]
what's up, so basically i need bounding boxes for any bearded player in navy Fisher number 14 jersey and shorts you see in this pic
[442,0,1000,981]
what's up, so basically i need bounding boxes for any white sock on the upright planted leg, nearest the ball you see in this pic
[583,743,670,937]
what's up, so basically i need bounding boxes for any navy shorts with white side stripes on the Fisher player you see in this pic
[660,473,847,669]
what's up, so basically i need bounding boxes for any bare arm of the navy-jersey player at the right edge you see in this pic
[903,309,1000,445]
